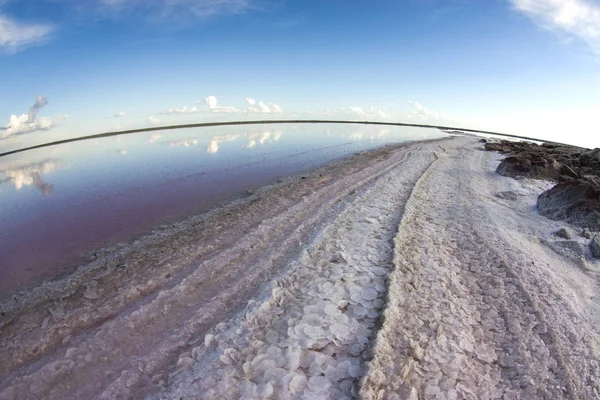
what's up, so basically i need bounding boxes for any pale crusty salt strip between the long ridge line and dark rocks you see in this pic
[360,142,600,400]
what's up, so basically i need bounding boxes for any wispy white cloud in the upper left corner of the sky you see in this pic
[0,14,54,52]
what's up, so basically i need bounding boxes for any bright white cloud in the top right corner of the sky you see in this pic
[510,0,600,53]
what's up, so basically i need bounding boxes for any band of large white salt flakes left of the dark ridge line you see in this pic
[155,148,433,399]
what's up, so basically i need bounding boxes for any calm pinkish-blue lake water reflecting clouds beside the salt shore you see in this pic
[0,124,443,297]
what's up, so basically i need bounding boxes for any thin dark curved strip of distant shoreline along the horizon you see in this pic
[0,120,577,157]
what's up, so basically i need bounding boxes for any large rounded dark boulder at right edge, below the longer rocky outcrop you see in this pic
[537,179,600,231]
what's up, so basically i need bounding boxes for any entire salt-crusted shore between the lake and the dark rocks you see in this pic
[0,138,600,399]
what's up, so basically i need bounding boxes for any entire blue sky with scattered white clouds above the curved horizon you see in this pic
[0,0,600,150]
